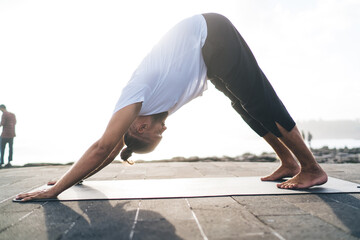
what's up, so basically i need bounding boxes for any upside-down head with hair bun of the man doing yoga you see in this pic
[121,112,168,160]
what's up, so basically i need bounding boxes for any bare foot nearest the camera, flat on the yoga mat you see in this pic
[277,166,327,189]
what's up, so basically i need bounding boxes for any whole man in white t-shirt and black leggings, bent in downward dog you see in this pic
[17,13,327,201]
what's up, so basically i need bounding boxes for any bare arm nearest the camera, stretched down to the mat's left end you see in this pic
[16,103,141,201]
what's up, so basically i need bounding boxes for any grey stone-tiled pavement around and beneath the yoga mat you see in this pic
[0,162,360,240]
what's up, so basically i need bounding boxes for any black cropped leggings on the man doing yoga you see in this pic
[202,13,295,137]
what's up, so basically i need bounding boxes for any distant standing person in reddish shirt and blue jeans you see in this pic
[0,104,16,166]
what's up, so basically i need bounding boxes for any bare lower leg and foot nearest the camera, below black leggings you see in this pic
[277,124,327,189]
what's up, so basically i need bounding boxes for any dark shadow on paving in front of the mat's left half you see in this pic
[43,187,181,240]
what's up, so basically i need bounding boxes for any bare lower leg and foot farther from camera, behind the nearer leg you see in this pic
[261,132,300,181]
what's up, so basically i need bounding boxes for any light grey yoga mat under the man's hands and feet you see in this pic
[13,177,360,201]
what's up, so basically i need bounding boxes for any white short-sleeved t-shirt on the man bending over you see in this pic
[114,15,207,116]
